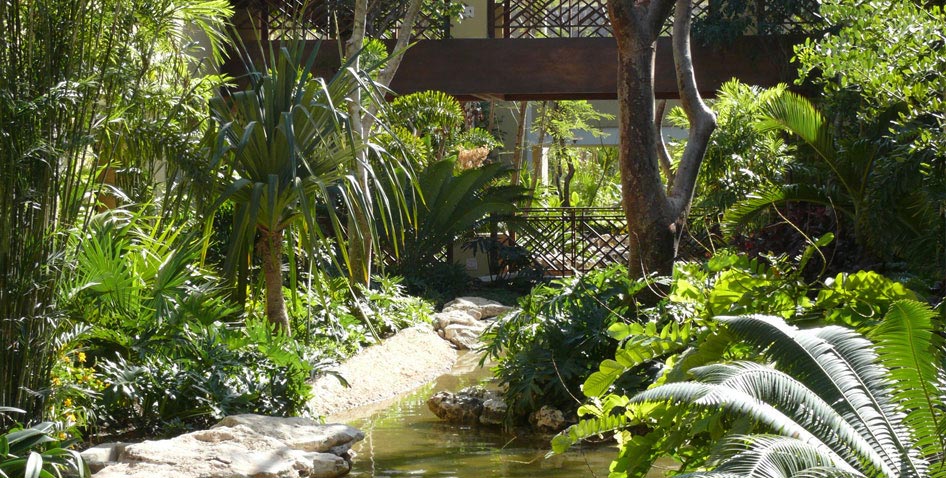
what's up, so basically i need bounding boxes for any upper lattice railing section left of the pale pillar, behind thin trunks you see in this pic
[236,0,450,40]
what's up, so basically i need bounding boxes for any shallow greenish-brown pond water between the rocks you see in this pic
[330,354,661,478]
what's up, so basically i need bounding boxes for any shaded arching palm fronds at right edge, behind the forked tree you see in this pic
[723,91,943,267]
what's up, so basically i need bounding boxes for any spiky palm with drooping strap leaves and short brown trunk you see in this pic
[211,41,397,332]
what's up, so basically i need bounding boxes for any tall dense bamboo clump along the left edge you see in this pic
[0,0,231,421]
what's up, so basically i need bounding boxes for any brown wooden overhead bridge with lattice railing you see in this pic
[233,0,817,100]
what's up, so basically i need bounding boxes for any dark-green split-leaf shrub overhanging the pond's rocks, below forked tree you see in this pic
[485,266,646,418]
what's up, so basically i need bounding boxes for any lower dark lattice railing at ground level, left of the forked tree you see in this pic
[498,208,627,275]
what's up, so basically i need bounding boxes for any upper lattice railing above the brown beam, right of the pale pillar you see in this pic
[487,0,819,38]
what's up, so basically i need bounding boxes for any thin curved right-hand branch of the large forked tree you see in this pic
[668,0,716,216]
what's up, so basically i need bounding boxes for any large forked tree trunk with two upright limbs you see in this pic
[608,0,715,277]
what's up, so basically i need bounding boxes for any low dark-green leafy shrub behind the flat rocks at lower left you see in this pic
[96,320,318,433]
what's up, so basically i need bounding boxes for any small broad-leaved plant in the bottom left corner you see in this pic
[0,407,91,478]
